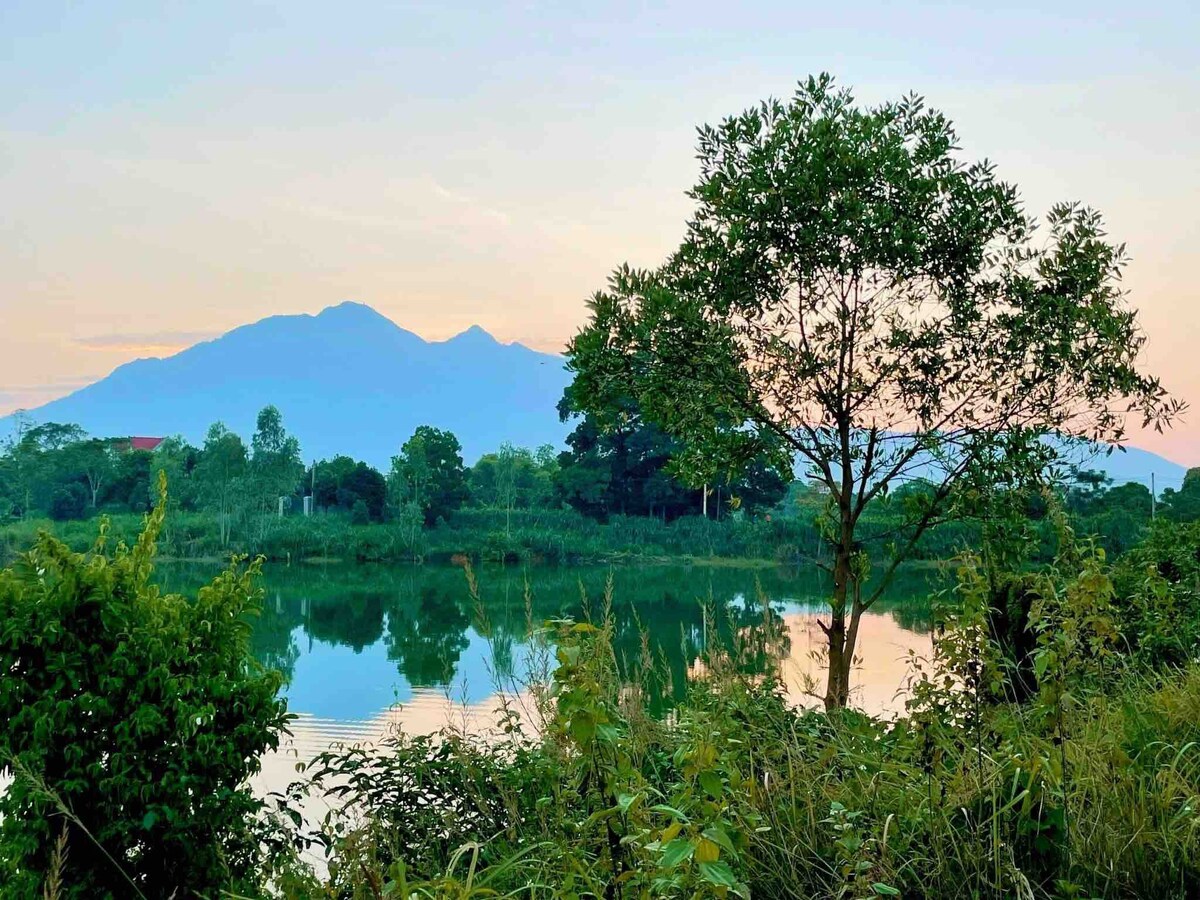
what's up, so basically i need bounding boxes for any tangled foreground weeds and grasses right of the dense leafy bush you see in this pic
[280,533,1200,898]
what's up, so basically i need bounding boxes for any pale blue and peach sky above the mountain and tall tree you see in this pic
[0,0,1200,464]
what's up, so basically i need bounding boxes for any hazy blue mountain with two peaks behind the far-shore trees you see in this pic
[0,302,570,467]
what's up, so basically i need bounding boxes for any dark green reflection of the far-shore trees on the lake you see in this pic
[154,565,931,719]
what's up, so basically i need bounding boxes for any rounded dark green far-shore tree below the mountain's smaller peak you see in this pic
[389,425,468,524]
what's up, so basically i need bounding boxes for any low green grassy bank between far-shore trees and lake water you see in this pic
[0,509,968,565]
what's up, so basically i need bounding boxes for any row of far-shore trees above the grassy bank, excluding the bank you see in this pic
[0,407,786,547]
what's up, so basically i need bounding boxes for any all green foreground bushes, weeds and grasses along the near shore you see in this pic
[0,496,1200,898]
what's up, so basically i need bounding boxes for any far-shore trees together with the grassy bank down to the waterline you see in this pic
[0,401,1200,562]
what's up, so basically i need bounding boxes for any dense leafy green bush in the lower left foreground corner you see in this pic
[0,482,288,899]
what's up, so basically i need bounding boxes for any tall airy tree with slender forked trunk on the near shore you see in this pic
[569,76,1181,708]
